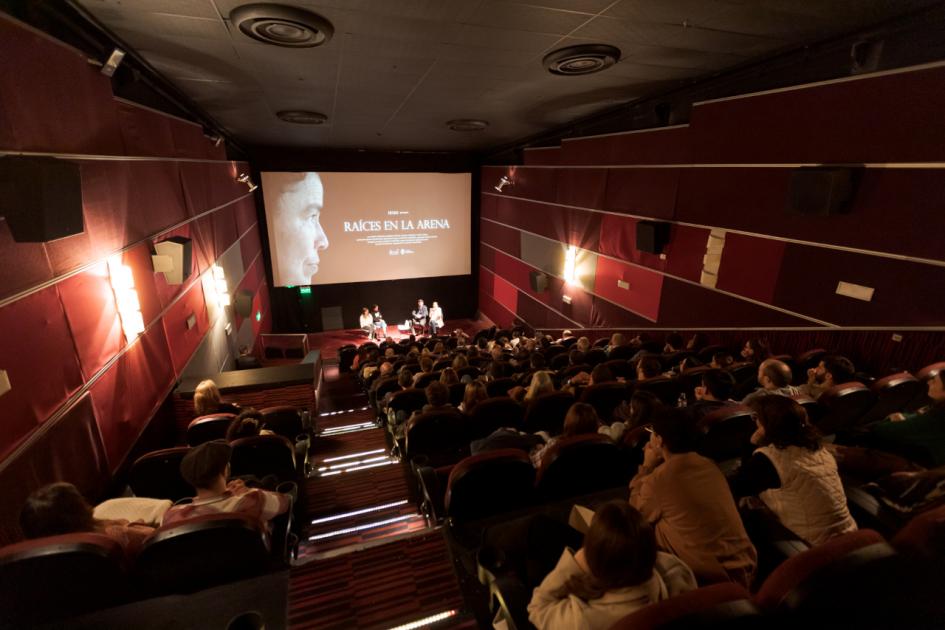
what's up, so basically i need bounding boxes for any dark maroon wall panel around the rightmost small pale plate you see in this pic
[772,244,945,326]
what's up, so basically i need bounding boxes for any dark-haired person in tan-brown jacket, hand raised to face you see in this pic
[630,408,758,588]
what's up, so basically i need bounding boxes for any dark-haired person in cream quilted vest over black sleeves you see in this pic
[732,396,856,545]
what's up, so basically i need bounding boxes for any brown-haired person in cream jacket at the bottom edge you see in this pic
[528,501,696,630]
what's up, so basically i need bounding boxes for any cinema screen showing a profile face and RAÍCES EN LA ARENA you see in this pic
[262,172,472,286]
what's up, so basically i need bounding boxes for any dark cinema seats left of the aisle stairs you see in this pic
[0,406,313,627]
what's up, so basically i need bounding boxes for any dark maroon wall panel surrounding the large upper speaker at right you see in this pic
[676,168,945,260]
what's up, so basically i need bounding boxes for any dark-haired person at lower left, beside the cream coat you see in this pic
[19,482,159,556]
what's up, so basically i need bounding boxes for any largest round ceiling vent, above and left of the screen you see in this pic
[230,3,335,48]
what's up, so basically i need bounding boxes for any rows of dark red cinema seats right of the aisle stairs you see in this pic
[343,330,945,628]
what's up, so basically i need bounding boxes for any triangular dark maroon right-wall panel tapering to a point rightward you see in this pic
[658,278,818,328]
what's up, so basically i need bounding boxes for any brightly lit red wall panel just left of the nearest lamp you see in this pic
[57,263,125,381]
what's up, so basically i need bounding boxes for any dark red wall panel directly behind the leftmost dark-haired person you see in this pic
[0,394,108,548]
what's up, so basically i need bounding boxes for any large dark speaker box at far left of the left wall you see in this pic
[0,155,84,243]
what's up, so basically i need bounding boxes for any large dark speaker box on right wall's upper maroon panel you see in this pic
[787,166,863,216]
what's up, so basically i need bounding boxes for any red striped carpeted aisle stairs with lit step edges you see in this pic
[289,366,468,629]
